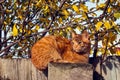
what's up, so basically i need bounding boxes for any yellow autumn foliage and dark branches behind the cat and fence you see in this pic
[0,0,120,58]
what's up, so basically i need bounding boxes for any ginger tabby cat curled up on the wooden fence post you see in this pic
[31,31,90,70]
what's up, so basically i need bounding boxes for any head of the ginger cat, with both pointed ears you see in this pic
[71,31,90,54]
